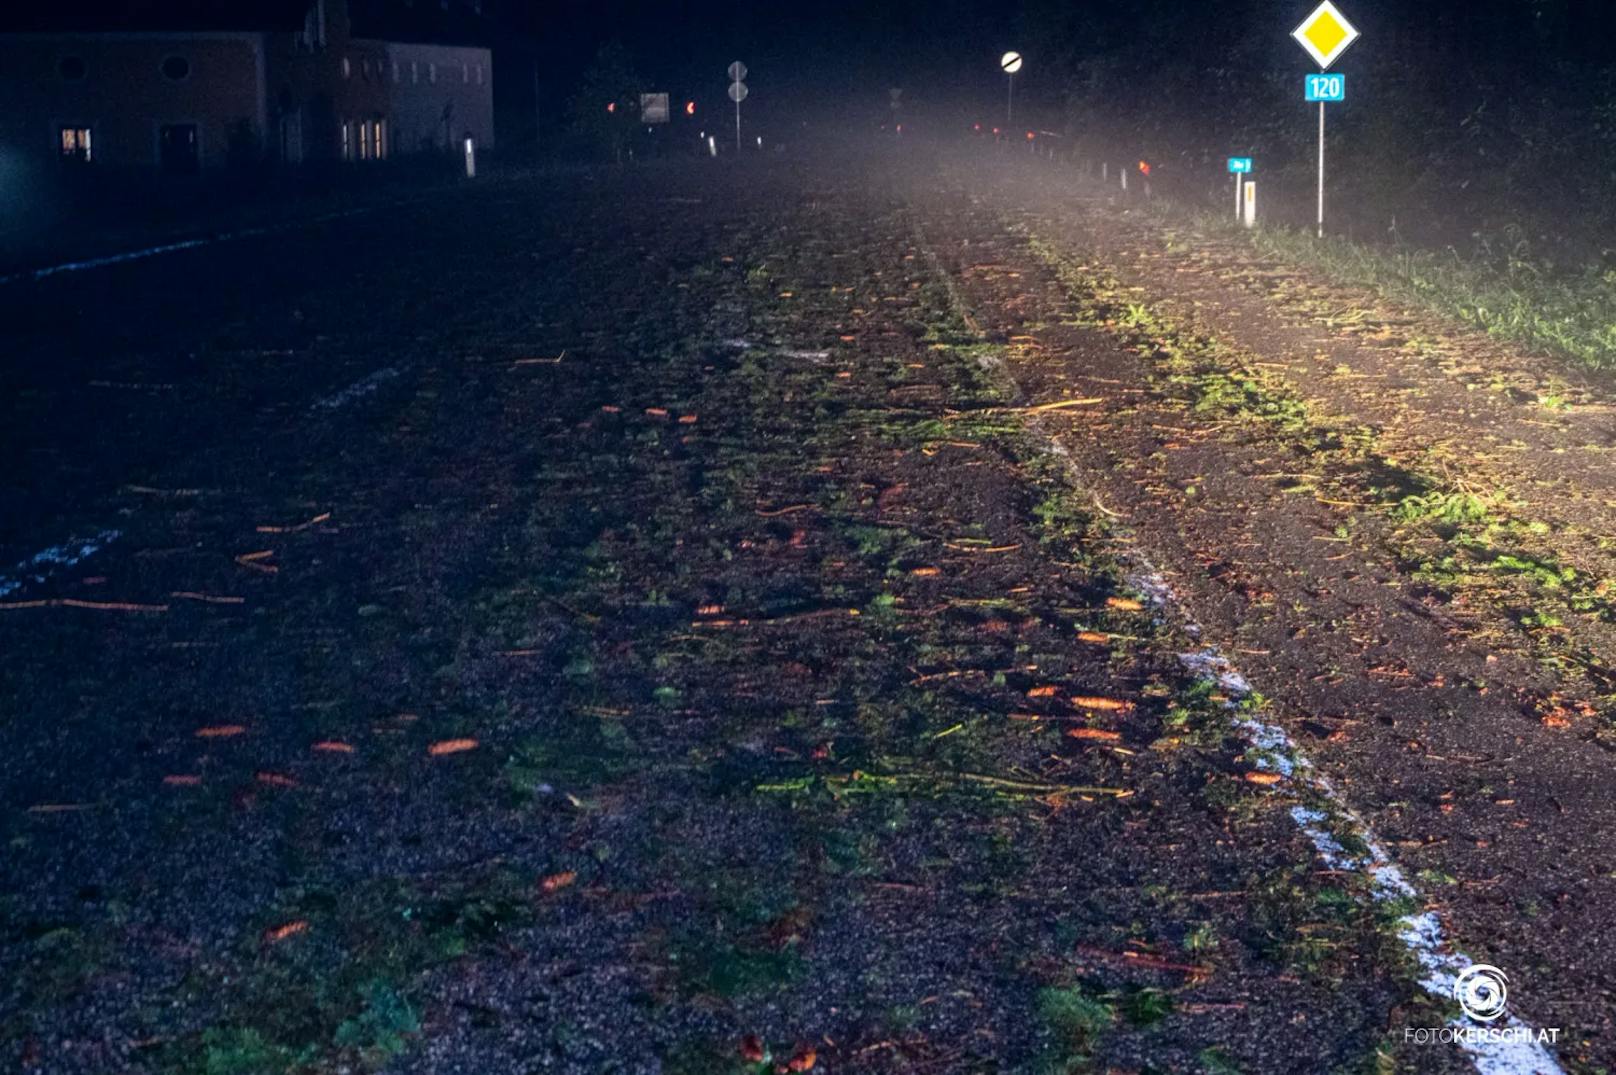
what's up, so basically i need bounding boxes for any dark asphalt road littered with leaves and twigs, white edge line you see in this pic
[0,139,1616,1075]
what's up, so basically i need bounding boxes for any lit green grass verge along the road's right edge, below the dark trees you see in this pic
[1157,202,1616,373]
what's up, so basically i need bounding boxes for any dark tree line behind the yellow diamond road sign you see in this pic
[1021,0,1616,262]
